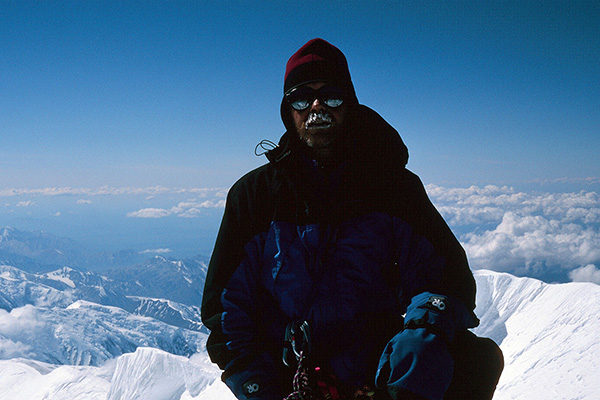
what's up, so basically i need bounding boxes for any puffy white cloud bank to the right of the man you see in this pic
[427,185,600,283]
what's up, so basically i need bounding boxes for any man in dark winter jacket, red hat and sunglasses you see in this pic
[202,39,502,400]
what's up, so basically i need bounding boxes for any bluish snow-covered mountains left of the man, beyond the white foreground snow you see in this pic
[0,266,206,365]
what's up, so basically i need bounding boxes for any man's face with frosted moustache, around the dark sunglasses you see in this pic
[292,82,346,150]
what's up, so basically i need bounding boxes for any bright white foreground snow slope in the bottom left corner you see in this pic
[0,347,235,400]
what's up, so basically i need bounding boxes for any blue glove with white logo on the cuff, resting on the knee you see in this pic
[376,292,479,400]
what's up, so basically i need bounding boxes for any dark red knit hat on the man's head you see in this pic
[283,39,358,103]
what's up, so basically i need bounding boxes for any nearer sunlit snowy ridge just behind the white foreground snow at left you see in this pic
[0,300,206,365]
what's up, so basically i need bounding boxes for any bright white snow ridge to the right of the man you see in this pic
[475,271,600,400]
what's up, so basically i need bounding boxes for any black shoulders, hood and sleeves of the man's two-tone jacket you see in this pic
[202,106,476,396]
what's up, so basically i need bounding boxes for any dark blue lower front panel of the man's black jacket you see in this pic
[222,213,462,387]
